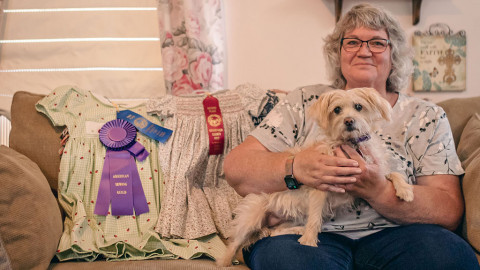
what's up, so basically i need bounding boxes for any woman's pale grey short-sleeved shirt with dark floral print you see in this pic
[251,85,463,238]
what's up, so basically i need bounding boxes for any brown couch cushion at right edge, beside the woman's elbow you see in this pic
[458,114,480,258]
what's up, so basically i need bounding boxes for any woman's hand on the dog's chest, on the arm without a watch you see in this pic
[335,145,388,201]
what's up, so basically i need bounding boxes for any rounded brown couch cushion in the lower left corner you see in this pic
[0,146,62,269]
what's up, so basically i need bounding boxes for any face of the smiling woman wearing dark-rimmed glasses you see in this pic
[340,27,392,92]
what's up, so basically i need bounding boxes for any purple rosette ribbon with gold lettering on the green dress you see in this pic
[93,119,149,216]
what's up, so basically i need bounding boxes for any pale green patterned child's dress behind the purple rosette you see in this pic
[36,86,225,261]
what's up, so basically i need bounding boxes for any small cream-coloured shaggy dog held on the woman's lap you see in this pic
[217,88,413,266]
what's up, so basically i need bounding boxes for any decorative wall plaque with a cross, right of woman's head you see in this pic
[412,23,467,92]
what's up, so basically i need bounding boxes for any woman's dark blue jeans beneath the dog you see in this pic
[243,224,480,270]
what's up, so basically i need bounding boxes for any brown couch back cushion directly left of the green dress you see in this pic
[9,91,63,192]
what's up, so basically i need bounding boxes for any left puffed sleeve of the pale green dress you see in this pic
[35,86,86,126]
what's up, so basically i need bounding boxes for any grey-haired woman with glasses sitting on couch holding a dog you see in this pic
[224,4,479,269]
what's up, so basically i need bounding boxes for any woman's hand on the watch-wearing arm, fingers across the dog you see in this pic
[293,146,362,193]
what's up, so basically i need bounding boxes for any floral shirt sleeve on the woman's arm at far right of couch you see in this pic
[408,105,464,176]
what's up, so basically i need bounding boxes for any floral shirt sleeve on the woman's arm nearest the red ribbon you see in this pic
[250,89,305,152]
